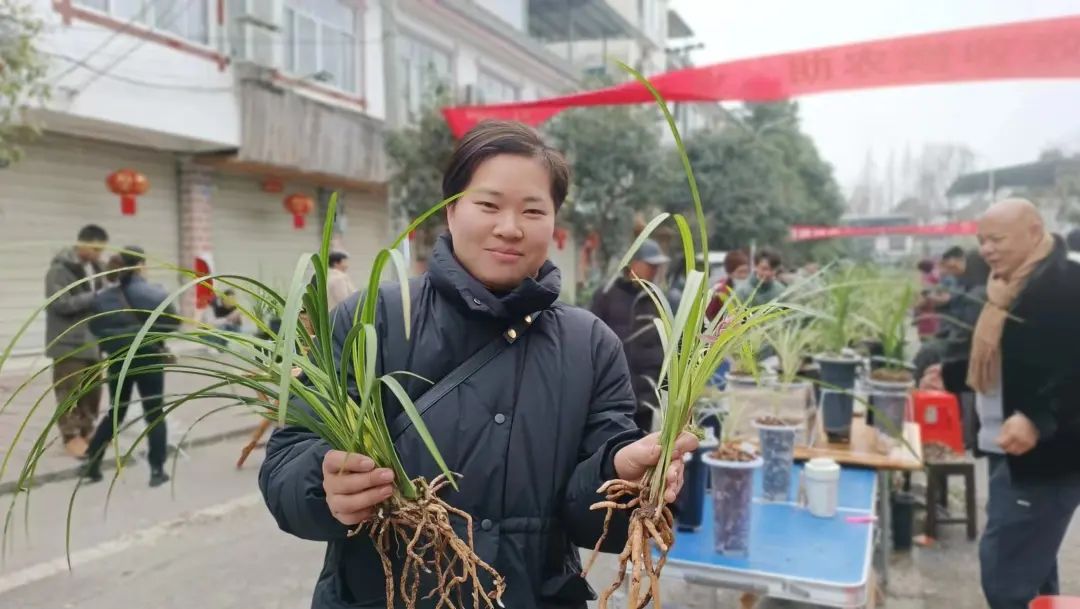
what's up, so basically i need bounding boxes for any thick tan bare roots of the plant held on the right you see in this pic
[582,479,675,609]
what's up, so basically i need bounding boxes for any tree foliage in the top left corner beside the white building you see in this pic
[0,0,49,166]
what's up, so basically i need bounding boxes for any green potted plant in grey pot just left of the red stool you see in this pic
[865,282,916,435]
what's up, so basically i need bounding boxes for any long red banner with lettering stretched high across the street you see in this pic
[443,15,1080,137]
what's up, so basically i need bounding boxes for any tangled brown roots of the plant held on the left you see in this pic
[349,476,507,609]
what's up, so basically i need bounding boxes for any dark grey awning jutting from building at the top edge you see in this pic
[528,0,639,42]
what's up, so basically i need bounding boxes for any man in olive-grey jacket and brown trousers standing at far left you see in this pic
[45,225,109,457]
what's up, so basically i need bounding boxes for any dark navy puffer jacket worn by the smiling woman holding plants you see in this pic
[259,236,642,609]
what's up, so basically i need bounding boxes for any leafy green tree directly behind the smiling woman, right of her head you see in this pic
[546,101,670,273]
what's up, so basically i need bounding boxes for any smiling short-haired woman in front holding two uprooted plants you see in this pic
[259,122,697,609]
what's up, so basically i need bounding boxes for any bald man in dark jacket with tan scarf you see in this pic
[945,200,1080,609]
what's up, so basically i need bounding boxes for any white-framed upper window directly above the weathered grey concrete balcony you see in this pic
[283,0,360,93]
